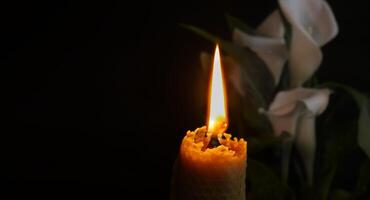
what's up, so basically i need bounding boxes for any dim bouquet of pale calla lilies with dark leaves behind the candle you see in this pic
[183,0,370,199]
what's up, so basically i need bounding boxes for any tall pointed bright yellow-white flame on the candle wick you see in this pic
[207,45,227,134]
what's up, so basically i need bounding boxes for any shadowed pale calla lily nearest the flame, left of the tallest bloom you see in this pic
[233,29,288,84]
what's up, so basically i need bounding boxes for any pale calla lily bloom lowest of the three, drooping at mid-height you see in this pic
[265,87,331,183]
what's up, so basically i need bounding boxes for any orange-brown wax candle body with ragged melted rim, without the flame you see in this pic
[171,127,247,200]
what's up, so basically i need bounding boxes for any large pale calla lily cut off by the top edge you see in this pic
[279,0,338,87]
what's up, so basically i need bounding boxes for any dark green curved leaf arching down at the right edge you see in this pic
[322,82,370,158]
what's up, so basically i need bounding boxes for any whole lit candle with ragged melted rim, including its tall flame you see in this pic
[171,46,247,200]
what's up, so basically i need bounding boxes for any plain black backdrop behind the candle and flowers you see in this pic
[5,0,370,199]
